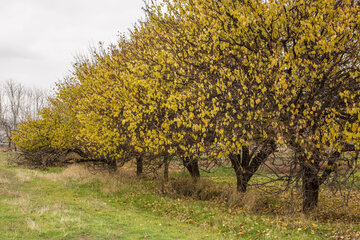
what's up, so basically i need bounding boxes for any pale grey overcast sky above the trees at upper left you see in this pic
[0,0,144,89]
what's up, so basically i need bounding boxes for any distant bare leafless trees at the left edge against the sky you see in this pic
[0,80,47,148]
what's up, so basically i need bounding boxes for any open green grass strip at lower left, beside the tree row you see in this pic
[0,153,221,239]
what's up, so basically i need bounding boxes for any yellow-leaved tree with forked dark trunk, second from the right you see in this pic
[142,1,276,191]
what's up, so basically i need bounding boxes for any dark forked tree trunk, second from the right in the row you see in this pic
[229,141,275,192]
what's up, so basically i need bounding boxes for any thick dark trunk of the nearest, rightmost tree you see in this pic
[302,166,320,213]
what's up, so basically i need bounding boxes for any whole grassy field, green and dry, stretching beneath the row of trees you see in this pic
[0,153,360,239]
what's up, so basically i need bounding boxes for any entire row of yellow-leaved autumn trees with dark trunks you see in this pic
[15,0,360,211]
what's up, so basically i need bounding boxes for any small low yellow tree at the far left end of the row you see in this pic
[14,91,84,167]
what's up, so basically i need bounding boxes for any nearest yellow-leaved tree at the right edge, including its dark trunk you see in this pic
[270,1,360,212]
